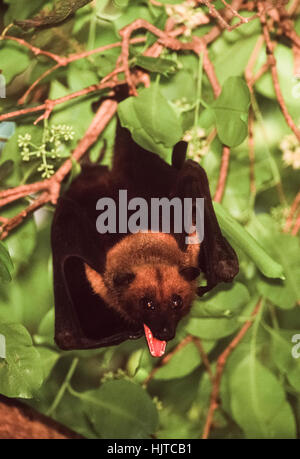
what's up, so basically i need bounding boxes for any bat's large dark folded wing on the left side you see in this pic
[51,166,143,350]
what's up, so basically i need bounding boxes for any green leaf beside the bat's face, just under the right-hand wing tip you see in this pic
[190,282,250,318]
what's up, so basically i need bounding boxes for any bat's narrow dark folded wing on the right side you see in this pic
[172,154,239,296]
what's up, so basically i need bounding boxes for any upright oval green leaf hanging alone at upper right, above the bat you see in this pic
[212,77,250,147]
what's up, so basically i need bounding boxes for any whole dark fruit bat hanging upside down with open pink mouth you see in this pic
[51,105,238,357]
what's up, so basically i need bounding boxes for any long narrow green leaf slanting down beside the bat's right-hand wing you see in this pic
[213,202,284,279]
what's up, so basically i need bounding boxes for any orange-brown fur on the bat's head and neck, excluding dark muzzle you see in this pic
[85,232,200,328]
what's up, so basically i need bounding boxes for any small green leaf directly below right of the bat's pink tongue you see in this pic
[154,341,214,380]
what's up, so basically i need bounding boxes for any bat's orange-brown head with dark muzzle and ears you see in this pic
[109,263,200,341]
